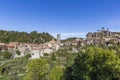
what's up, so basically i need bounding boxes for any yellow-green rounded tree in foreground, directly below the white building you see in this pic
[25,59,50,80]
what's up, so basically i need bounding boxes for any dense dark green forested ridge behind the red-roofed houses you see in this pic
[0,30,53,44]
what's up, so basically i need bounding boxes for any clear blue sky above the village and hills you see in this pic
[0,0,120,39]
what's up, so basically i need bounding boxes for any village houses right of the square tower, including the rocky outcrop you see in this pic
[64,28,120,46]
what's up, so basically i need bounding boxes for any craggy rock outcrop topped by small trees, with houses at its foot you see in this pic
[86,28,120,46]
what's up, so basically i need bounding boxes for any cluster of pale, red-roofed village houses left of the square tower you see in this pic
[0,39,59,59]
